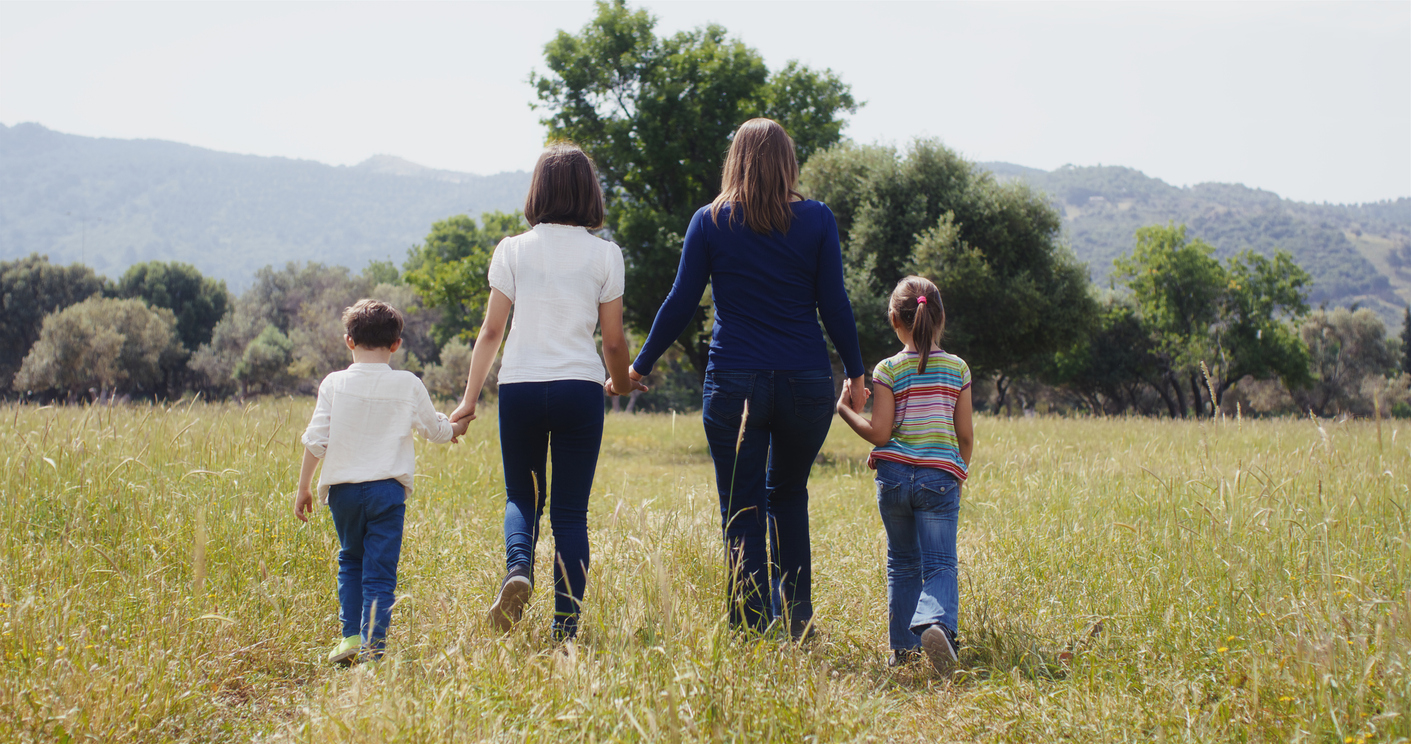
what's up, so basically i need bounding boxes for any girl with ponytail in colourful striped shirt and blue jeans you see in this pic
[838,277,975,672]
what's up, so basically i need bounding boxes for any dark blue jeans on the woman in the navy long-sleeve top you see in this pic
[703,370,834,630]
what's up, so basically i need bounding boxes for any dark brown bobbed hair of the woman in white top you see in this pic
[525,143,602,230]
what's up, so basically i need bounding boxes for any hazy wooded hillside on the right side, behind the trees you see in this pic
[979,162,1411,326]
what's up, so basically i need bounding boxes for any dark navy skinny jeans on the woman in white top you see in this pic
[499,380,602,637]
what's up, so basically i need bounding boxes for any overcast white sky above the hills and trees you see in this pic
[0,0,1411,202]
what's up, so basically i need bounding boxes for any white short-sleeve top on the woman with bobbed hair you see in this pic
[490,223,624,384]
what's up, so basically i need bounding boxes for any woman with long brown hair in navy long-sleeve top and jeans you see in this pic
[629,119,866,637]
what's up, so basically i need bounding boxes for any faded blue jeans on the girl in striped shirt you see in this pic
[876,460,961,649]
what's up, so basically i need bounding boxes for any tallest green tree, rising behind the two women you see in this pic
[531,0,858,374]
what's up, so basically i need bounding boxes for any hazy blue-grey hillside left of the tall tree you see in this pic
[0,124,529,289]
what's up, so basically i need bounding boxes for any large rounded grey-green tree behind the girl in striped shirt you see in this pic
[803,140,1098,411]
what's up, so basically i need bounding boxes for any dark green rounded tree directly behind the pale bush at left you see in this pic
[113,261,231,352]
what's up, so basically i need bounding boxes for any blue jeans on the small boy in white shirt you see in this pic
[329,479,406,651]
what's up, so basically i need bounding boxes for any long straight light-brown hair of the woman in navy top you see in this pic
[710,119,803,233]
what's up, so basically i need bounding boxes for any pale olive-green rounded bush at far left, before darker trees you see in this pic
[14,296,182,398]
